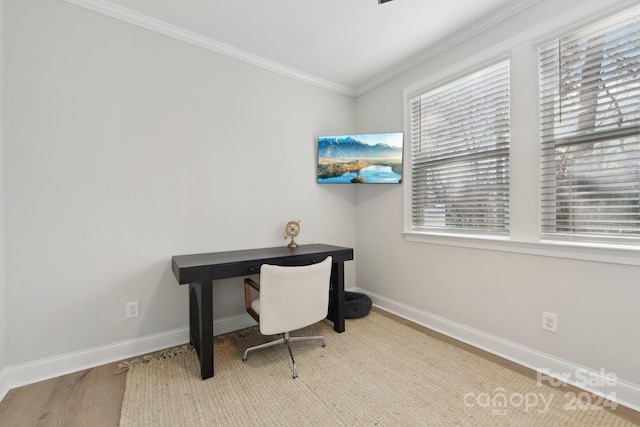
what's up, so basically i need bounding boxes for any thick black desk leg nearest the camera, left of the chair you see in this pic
[189,283,213,380]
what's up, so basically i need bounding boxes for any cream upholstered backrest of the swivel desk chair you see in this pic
[260,257,332,335]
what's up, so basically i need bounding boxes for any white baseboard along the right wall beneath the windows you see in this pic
[358,289,640,411]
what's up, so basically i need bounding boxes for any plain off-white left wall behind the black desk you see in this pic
[0,0,355,386]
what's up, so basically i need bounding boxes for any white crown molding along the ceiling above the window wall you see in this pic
[355,0,542,97]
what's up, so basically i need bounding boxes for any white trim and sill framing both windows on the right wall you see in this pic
[400,2,640,266]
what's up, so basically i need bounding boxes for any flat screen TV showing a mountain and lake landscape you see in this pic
[318,132,403,184]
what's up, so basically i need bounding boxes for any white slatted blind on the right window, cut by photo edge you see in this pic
[539,9,640,241]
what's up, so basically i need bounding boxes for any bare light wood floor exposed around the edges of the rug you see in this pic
[0,308,640,427]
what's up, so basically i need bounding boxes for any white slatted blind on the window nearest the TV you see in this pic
[409,61,509,234]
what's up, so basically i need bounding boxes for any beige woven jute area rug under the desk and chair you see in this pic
[120,312,631,427]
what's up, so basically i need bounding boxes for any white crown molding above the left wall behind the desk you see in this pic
[62,0,355,98]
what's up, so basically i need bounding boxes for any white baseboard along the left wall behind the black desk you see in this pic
[0,314,256,400]
